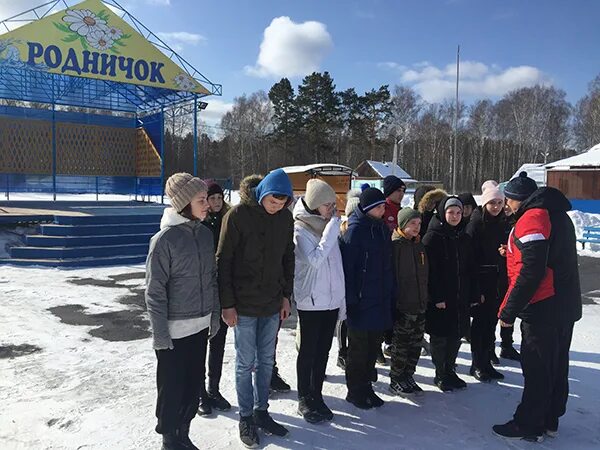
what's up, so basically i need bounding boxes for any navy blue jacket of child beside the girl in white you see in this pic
[340,208,394,331]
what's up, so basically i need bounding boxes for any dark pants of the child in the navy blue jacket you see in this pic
[346,327,383,395]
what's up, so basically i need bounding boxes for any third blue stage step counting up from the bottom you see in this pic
[25,233,152,247]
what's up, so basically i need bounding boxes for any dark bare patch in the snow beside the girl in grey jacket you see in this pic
[48,272,151,342]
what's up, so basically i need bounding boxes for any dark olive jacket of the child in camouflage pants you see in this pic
[392,230,429,314]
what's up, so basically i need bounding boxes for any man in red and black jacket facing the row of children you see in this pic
[493,172,581,442]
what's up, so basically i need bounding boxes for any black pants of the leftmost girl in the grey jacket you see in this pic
[156,329,208,434]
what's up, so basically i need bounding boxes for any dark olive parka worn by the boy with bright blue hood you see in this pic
[217,175,295,317]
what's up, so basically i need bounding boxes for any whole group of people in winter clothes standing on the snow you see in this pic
[146,169,581,450]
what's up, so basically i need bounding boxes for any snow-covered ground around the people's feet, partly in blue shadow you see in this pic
[0,266,600,450]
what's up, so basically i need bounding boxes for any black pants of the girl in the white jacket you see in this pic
[296,309,339,397]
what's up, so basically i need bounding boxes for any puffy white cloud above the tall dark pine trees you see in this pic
[244,16,333,78]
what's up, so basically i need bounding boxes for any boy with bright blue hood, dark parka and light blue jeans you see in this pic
[217,169,295,448]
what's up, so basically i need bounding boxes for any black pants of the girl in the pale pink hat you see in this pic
[471,302,498,369]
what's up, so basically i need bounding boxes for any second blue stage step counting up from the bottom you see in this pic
[10,243,148,259]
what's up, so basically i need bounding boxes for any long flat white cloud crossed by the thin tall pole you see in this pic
[378,61,550,102]
